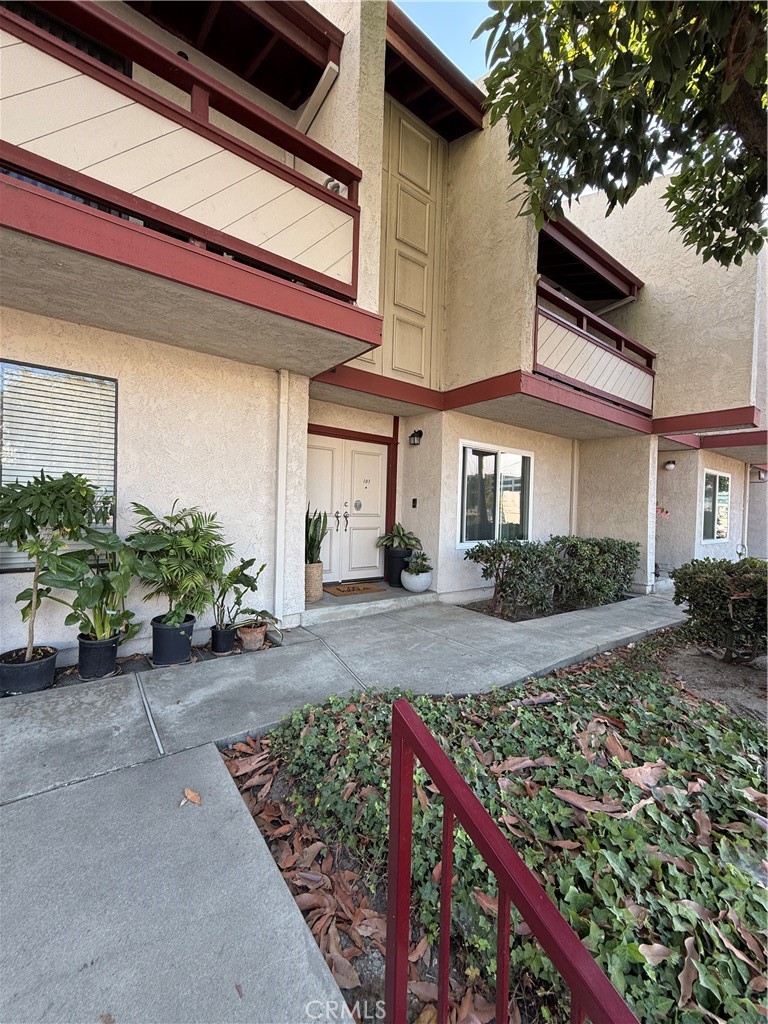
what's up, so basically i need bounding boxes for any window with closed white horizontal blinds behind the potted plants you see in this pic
[0,361,118,572]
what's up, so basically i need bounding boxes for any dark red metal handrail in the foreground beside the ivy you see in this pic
[385,699,638,1024]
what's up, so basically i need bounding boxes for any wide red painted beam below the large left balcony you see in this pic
[0,177,382,348]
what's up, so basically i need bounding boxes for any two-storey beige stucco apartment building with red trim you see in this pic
[0,0,768,647]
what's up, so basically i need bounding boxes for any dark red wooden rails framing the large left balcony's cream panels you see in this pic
[0,0,361,299]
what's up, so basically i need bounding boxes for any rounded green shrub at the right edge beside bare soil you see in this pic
[670,558,768,662]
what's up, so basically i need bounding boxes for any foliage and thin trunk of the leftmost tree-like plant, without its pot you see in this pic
[0,469,114,662]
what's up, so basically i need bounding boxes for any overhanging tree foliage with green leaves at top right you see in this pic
[483,0,767,266]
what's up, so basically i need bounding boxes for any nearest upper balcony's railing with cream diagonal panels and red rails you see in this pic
[0,4,360,299]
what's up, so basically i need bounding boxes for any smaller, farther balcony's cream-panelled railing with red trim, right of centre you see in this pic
[534,281,655,416]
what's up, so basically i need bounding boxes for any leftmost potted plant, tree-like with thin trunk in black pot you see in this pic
[0,469,113,694]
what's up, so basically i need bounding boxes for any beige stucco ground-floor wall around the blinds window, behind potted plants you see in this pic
[0,309,308,650]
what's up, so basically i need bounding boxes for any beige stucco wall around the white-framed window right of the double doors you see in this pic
[398,413,572,598]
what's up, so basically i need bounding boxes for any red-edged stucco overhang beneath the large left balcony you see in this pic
[0,180,382,377]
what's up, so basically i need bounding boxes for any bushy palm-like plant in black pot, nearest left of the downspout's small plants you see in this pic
[128,501,232,666]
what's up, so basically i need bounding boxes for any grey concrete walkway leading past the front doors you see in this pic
[0,597,684,1024]
